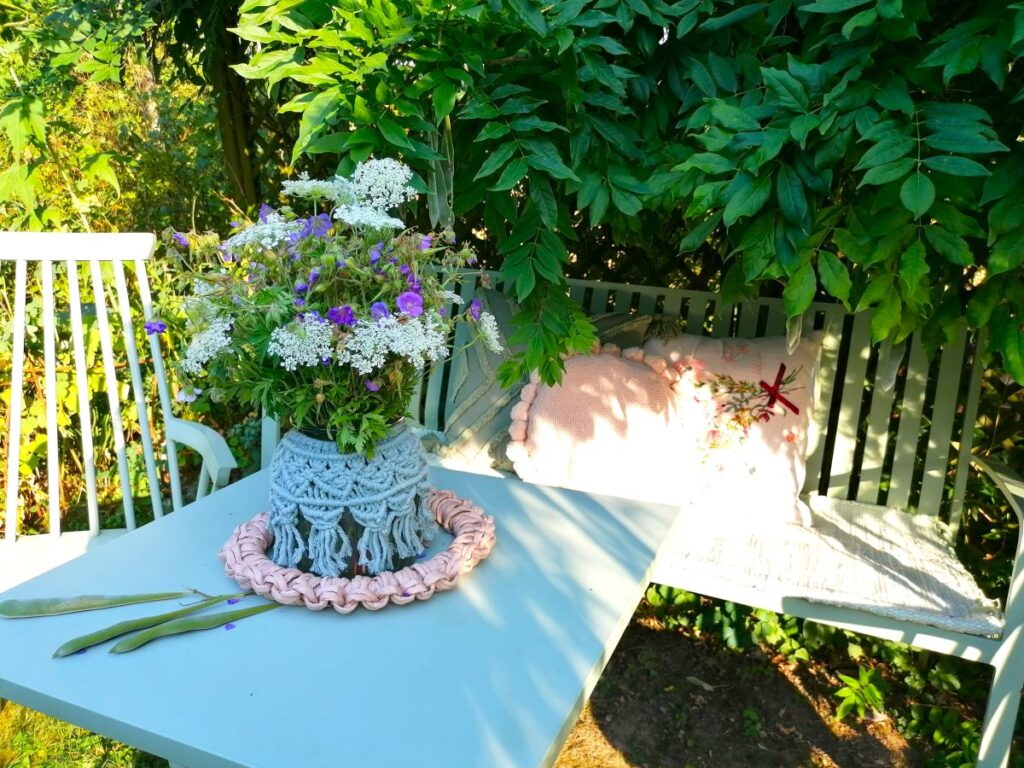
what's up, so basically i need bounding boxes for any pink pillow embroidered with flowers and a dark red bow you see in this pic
[644,334,821,525]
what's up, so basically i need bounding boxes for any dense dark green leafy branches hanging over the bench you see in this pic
[236,0,1024,381]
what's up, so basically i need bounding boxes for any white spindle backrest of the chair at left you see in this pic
[0,232,180,542]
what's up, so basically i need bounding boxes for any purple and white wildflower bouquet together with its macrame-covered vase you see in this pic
[158,160,501,577]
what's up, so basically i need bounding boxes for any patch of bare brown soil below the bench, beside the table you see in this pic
[556,617,922,768]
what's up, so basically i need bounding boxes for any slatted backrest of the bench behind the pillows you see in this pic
[414,273,982,525]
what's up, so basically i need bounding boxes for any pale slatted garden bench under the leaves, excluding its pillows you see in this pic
[264,275,1024,768]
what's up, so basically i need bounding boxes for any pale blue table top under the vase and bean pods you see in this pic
[0,468,676,768]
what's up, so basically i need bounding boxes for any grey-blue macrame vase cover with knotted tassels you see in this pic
[269,424,437,577]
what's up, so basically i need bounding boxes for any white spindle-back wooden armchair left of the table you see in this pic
[0,232,236,591]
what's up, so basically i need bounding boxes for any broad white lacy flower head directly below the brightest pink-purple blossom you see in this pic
[337,312,449,376]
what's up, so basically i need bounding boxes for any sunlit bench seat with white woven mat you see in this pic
[652,497,1004,637]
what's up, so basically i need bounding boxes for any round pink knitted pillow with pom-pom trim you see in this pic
[508,344,697,504]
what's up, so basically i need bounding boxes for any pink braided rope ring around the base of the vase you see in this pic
[220,490,495,613]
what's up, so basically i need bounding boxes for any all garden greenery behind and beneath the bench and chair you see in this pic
[0,0,1024,765]
